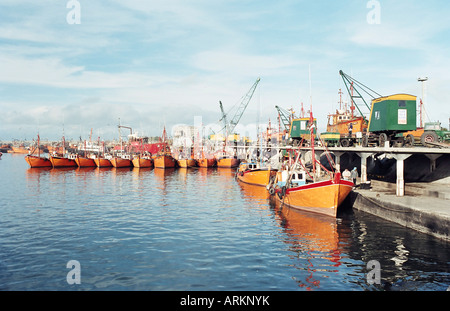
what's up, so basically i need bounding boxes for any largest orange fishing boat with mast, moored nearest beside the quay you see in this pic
[269,109,354,217]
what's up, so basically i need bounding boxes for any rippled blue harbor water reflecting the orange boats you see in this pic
[0,154,450,291]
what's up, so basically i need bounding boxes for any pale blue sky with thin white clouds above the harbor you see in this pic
[0,0,450,141]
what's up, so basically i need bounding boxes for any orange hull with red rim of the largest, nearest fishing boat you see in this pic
[277,180,353,217]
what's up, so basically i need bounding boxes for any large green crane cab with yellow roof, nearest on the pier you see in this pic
[369,94,417,133]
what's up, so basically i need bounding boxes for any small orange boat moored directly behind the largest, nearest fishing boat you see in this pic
[236,161,277,187]
